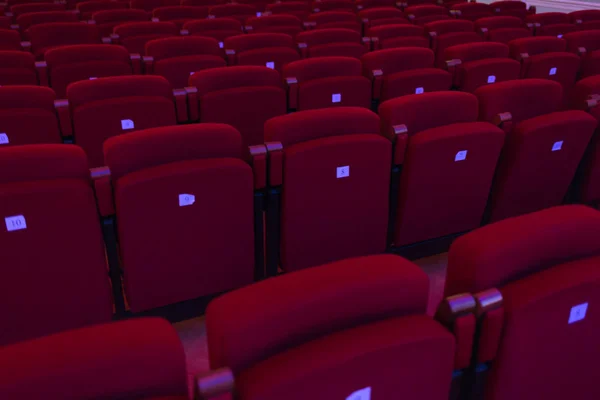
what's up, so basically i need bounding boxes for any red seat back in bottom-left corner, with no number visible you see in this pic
[0,318,187,399]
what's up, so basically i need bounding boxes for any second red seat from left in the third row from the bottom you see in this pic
[67,76,177,167]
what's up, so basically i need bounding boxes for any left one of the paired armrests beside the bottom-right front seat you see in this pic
[435,293,476,369]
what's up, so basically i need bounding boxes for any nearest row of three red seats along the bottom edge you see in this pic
[0,206,600,400]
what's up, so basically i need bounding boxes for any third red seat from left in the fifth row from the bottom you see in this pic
[111,22,179,54]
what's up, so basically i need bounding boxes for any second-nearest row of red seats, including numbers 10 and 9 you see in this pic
[0,80,600,343]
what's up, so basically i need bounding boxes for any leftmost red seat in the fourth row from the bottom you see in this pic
[0,50,38,86]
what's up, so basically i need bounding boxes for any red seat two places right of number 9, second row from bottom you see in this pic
[379,92,505,246]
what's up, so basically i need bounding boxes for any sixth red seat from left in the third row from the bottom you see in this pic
[444,42,521,92]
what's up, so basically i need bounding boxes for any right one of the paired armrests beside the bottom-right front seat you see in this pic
[475,289,504,362]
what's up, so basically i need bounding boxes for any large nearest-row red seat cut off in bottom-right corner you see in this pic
[446,206,600,400]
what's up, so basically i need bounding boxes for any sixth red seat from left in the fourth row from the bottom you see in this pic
[366,24,429,50]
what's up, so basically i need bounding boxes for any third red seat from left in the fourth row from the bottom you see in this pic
[145,36,227,88]
